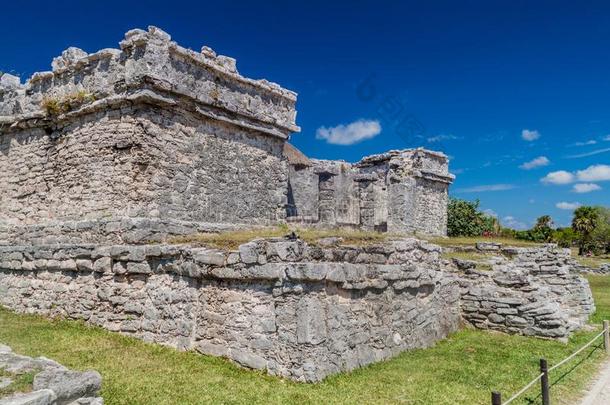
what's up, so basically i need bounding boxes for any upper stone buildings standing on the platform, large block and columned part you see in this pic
[0,27,453,235]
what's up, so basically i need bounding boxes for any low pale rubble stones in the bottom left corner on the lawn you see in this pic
[0,344,104,405]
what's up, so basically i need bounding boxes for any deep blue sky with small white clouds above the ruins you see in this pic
[0,0,610,227]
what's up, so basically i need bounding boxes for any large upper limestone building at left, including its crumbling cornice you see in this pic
[0,27,298,229]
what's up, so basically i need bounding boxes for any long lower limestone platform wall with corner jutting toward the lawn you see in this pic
[0,239,460,381]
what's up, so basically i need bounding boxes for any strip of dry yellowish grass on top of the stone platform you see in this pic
[170,226,397,250]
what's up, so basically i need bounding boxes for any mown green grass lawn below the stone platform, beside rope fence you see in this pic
[0,276,610,405]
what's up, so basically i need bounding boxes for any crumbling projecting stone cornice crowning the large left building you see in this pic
[0,27,300,139]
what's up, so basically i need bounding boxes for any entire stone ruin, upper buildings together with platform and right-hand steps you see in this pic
[0,27,594,381]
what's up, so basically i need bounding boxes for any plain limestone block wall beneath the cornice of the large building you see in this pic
[0,107,287,224]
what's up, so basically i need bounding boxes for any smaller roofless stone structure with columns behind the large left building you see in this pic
[287,149,454,235]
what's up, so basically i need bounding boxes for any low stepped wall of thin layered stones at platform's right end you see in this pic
[449,245,595,339]
